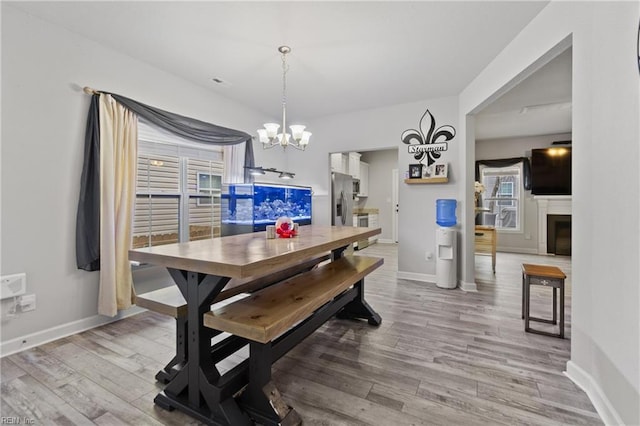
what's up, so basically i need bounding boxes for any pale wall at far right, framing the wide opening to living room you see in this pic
[460,2,640,425]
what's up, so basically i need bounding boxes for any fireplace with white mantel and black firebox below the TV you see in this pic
[533,195,571,256]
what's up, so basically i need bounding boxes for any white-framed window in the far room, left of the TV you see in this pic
[480,163,524,231]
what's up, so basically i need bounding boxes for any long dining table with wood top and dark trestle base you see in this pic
[129,225,381,426]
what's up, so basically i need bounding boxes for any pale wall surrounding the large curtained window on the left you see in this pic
[0,2,278,352]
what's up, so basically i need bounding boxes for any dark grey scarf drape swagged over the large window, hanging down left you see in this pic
[76,92,255,271]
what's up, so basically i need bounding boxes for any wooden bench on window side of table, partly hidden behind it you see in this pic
[136,253,330,384]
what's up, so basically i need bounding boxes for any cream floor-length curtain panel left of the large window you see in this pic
[98,94,138,316]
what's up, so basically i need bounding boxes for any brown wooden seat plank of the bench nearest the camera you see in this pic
[204,256,383,343]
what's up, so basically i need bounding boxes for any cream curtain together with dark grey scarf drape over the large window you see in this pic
[76,91,255,315]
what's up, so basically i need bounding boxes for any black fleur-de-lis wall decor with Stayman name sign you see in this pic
[401,110,456,167]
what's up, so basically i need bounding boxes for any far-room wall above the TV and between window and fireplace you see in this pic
[476,133,571,254]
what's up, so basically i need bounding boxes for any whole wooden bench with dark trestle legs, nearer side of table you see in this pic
[204,256,384,424]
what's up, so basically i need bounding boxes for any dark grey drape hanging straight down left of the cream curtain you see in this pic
[76,95,100,271]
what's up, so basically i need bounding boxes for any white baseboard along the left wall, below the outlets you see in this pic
[0,306,146,357]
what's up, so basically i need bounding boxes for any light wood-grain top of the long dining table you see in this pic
[129,225,381,278]
